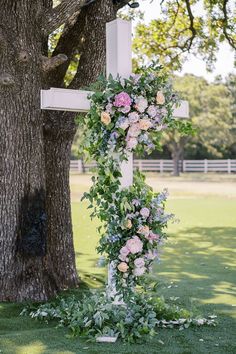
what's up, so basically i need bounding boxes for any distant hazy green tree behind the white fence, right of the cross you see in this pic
[163,75,235,176]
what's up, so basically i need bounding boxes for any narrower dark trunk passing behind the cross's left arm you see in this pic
[44,0,115,289]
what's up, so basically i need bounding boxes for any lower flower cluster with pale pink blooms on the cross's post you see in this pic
[97,173,173,294]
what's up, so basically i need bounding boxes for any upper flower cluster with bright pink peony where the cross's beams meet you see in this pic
[81,63,178,157]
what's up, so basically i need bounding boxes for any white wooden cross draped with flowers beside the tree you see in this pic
[41,19,189,304]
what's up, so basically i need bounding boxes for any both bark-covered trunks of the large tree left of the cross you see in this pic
[0,0,115,301]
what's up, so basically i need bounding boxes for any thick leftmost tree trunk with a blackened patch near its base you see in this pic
[0,0,56,301]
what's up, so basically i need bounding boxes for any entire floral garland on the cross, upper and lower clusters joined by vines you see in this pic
[79,66,190,295]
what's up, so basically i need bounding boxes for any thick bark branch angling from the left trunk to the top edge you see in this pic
[44,0,96,34]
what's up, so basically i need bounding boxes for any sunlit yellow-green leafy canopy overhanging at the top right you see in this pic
[134,0,236,71]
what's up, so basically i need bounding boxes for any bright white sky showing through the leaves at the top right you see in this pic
[133,0,236,81]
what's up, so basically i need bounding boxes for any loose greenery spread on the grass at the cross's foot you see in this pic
[21,291,215,343]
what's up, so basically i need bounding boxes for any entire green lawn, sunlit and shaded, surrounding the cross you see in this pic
[0,175,236,354]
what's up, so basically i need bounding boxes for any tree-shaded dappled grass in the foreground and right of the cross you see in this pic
[0,226,236,354]
